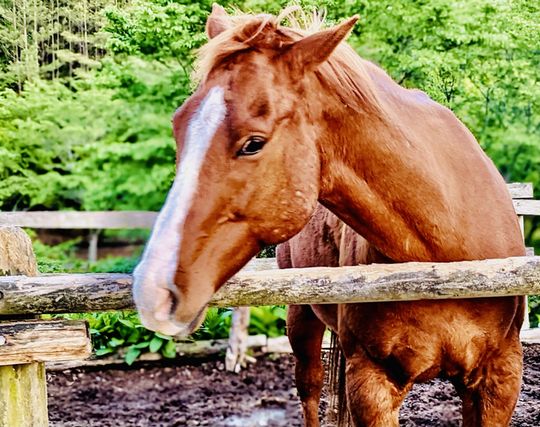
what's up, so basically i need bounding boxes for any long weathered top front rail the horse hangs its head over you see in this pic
[0,257,540,315]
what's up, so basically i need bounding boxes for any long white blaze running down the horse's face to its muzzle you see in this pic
[133,86,226,335]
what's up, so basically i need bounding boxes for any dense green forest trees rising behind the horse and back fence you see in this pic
[0,0,540,358]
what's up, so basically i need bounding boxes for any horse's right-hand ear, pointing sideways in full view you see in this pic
[283,15,358,74]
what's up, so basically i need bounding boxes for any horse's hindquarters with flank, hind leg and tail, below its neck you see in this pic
[276,205,384,426]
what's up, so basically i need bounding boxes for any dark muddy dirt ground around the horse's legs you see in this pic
[48,345,540,427]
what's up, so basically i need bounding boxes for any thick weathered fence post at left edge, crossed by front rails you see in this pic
[0,227,49,427]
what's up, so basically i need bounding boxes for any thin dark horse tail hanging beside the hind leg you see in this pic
[327,331,352,427]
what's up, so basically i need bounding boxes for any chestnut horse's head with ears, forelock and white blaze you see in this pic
[134,6,357,334]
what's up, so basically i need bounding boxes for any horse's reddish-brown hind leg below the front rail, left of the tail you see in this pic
[287,305,326,427]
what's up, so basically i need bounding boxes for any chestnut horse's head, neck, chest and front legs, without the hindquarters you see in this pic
[133,6,525,427]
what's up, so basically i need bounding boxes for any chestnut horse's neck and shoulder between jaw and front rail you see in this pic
[319,84,523,262]
